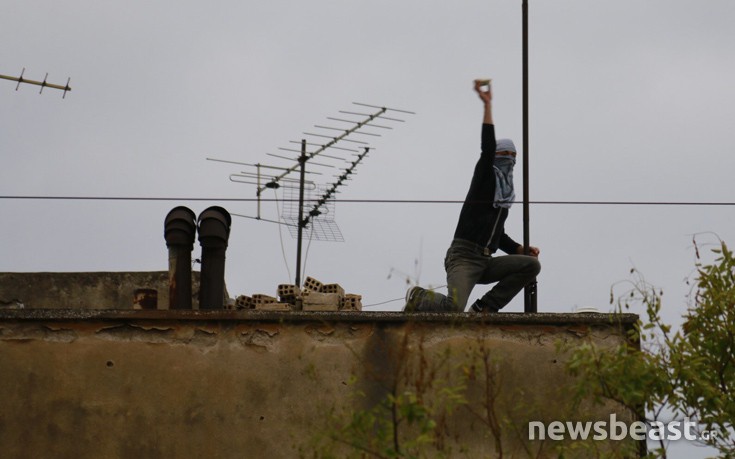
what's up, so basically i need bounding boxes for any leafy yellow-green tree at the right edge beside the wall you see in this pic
[567,241,735,458]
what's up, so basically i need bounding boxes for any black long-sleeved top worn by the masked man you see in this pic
[454,124,520,254]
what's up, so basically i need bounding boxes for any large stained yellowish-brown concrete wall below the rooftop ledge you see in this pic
[0,310,635,459]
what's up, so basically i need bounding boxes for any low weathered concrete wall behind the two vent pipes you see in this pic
[0,271,200,309]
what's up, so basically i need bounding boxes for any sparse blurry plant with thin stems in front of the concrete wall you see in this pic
[302,332,543,459]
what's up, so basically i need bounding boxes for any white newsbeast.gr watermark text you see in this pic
[528,413,717,441]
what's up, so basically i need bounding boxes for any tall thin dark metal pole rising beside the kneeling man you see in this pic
[522,0,538,312]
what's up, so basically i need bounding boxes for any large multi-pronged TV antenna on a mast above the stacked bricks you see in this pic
[207,102,415,285]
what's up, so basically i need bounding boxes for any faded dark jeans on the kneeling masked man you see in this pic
[416,239,541,312]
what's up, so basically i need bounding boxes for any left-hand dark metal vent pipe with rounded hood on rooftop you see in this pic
[163,206,196,309]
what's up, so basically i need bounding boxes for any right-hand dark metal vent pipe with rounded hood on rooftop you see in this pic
[197,206,232,309]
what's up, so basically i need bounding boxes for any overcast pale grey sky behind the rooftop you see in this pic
[0,0,735,320]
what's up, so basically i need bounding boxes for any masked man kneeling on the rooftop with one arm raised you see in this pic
[404,80,541,313]
